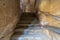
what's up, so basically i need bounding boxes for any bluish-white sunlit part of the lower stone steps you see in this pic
[18,27,51,40]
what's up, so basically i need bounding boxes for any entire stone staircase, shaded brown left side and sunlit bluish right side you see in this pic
[11,13,60,40]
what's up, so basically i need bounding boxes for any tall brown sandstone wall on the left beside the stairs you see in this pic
[0,0,20,40]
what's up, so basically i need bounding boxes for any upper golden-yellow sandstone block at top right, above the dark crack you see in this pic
[39,0,60,17]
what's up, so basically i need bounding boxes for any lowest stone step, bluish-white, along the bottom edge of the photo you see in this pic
[11,35,48,40]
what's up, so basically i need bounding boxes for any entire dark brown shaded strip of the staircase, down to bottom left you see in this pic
[11,13,37,40]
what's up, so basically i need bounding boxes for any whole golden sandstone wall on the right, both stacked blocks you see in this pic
[38,0,60,28]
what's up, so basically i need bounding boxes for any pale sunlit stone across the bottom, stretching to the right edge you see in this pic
[13,20,60,40]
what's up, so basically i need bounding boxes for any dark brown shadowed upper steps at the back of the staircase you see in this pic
[16,13,36,28]
